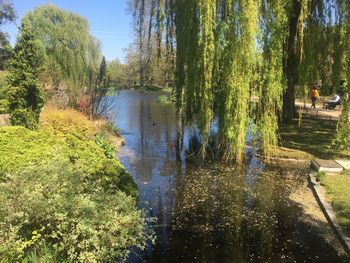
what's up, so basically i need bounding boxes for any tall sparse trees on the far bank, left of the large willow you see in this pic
[127,0,175,86]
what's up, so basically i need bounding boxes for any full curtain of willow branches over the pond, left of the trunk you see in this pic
[176,0,287,161]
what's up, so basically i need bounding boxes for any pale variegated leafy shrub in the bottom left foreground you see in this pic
[0,155,147,262]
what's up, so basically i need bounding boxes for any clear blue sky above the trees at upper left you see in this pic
[2,0,132,61]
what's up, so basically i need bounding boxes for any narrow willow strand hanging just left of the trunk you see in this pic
[257,0,288,155]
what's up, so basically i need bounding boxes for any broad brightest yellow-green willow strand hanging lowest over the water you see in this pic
[217,0,260,161]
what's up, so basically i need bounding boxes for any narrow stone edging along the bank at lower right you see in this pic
[309,174,350,255]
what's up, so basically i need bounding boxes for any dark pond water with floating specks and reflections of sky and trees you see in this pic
[114,91,348,263]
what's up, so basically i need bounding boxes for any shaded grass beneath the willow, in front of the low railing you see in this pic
[280,117,350,159]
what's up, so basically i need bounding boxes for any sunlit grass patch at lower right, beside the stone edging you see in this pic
[322,171,350,235]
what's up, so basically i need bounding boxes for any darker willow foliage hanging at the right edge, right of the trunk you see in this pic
[299,0,350,150]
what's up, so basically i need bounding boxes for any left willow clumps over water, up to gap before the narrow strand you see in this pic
[172,0,260,161]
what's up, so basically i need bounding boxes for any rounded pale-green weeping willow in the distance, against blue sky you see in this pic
[26,4,101,103]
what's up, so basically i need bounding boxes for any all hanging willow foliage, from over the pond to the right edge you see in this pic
[161,0,350,161]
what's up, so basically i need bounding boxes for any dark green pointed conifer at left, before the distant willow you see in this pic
[7,19,44,129]
